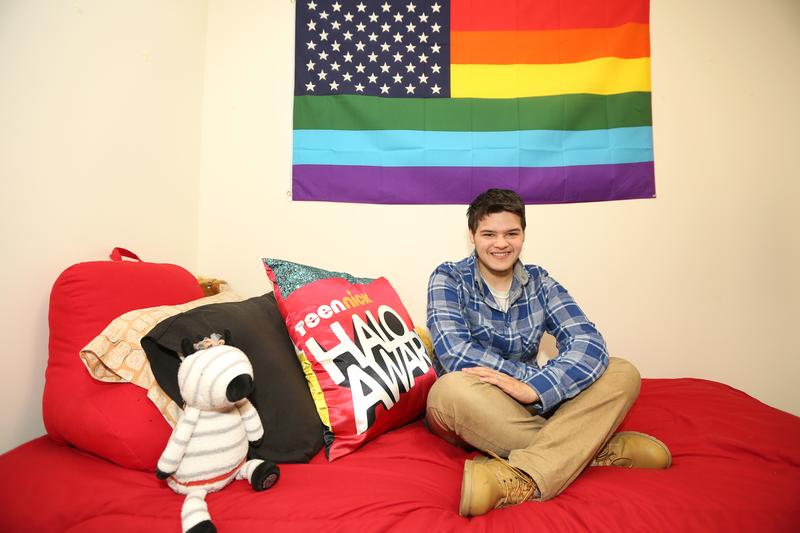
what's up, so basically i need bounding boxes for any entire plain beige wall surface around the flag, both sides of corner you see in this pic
[0,0,800,451]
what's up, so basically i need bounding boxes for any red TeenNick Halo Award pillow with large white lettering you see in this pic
[264,259,436,461]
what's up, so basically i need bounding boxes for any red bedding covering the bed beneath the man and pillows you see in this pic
[0,379,800,533]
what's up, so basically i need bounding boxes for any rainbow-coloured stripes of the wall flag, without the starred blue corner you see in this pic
[293,0,655,204]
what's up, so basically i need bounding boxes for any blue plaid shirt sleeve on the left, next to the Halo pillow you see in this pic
[428,265,535,381]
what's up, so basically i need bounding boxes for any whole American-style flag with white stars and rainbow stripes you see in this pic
[292,0,655,204]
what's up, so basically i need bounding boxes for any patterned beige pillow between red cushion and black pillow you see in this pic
[81,290,242,427]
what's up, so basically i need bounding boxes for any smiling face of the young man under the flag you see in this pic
[469,211,525,287]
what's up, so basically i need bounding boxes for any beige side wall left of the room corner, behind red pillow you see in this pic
[0,0,206,452]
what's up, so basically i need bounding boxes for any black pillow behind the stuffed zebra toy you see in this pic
[142,293,324,463]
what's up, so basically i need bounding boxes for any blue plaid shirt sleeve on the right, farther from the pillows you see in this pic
[525,272,608,412]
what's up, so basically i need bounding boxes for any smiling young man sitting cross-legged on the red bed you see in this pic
[426,189,671,516]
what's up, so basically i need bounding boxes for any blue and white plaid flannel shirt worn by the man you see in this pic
[428,253,608,413]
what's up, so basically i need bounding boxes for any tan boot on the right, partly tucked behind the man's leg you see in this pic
[589,431,672,468]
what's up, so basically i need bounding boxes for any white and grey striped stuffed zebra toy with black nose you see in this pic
[156,331,280,533]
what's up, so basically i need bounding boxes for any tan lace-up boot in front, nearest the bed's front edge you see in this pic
[458,455,536,516]
